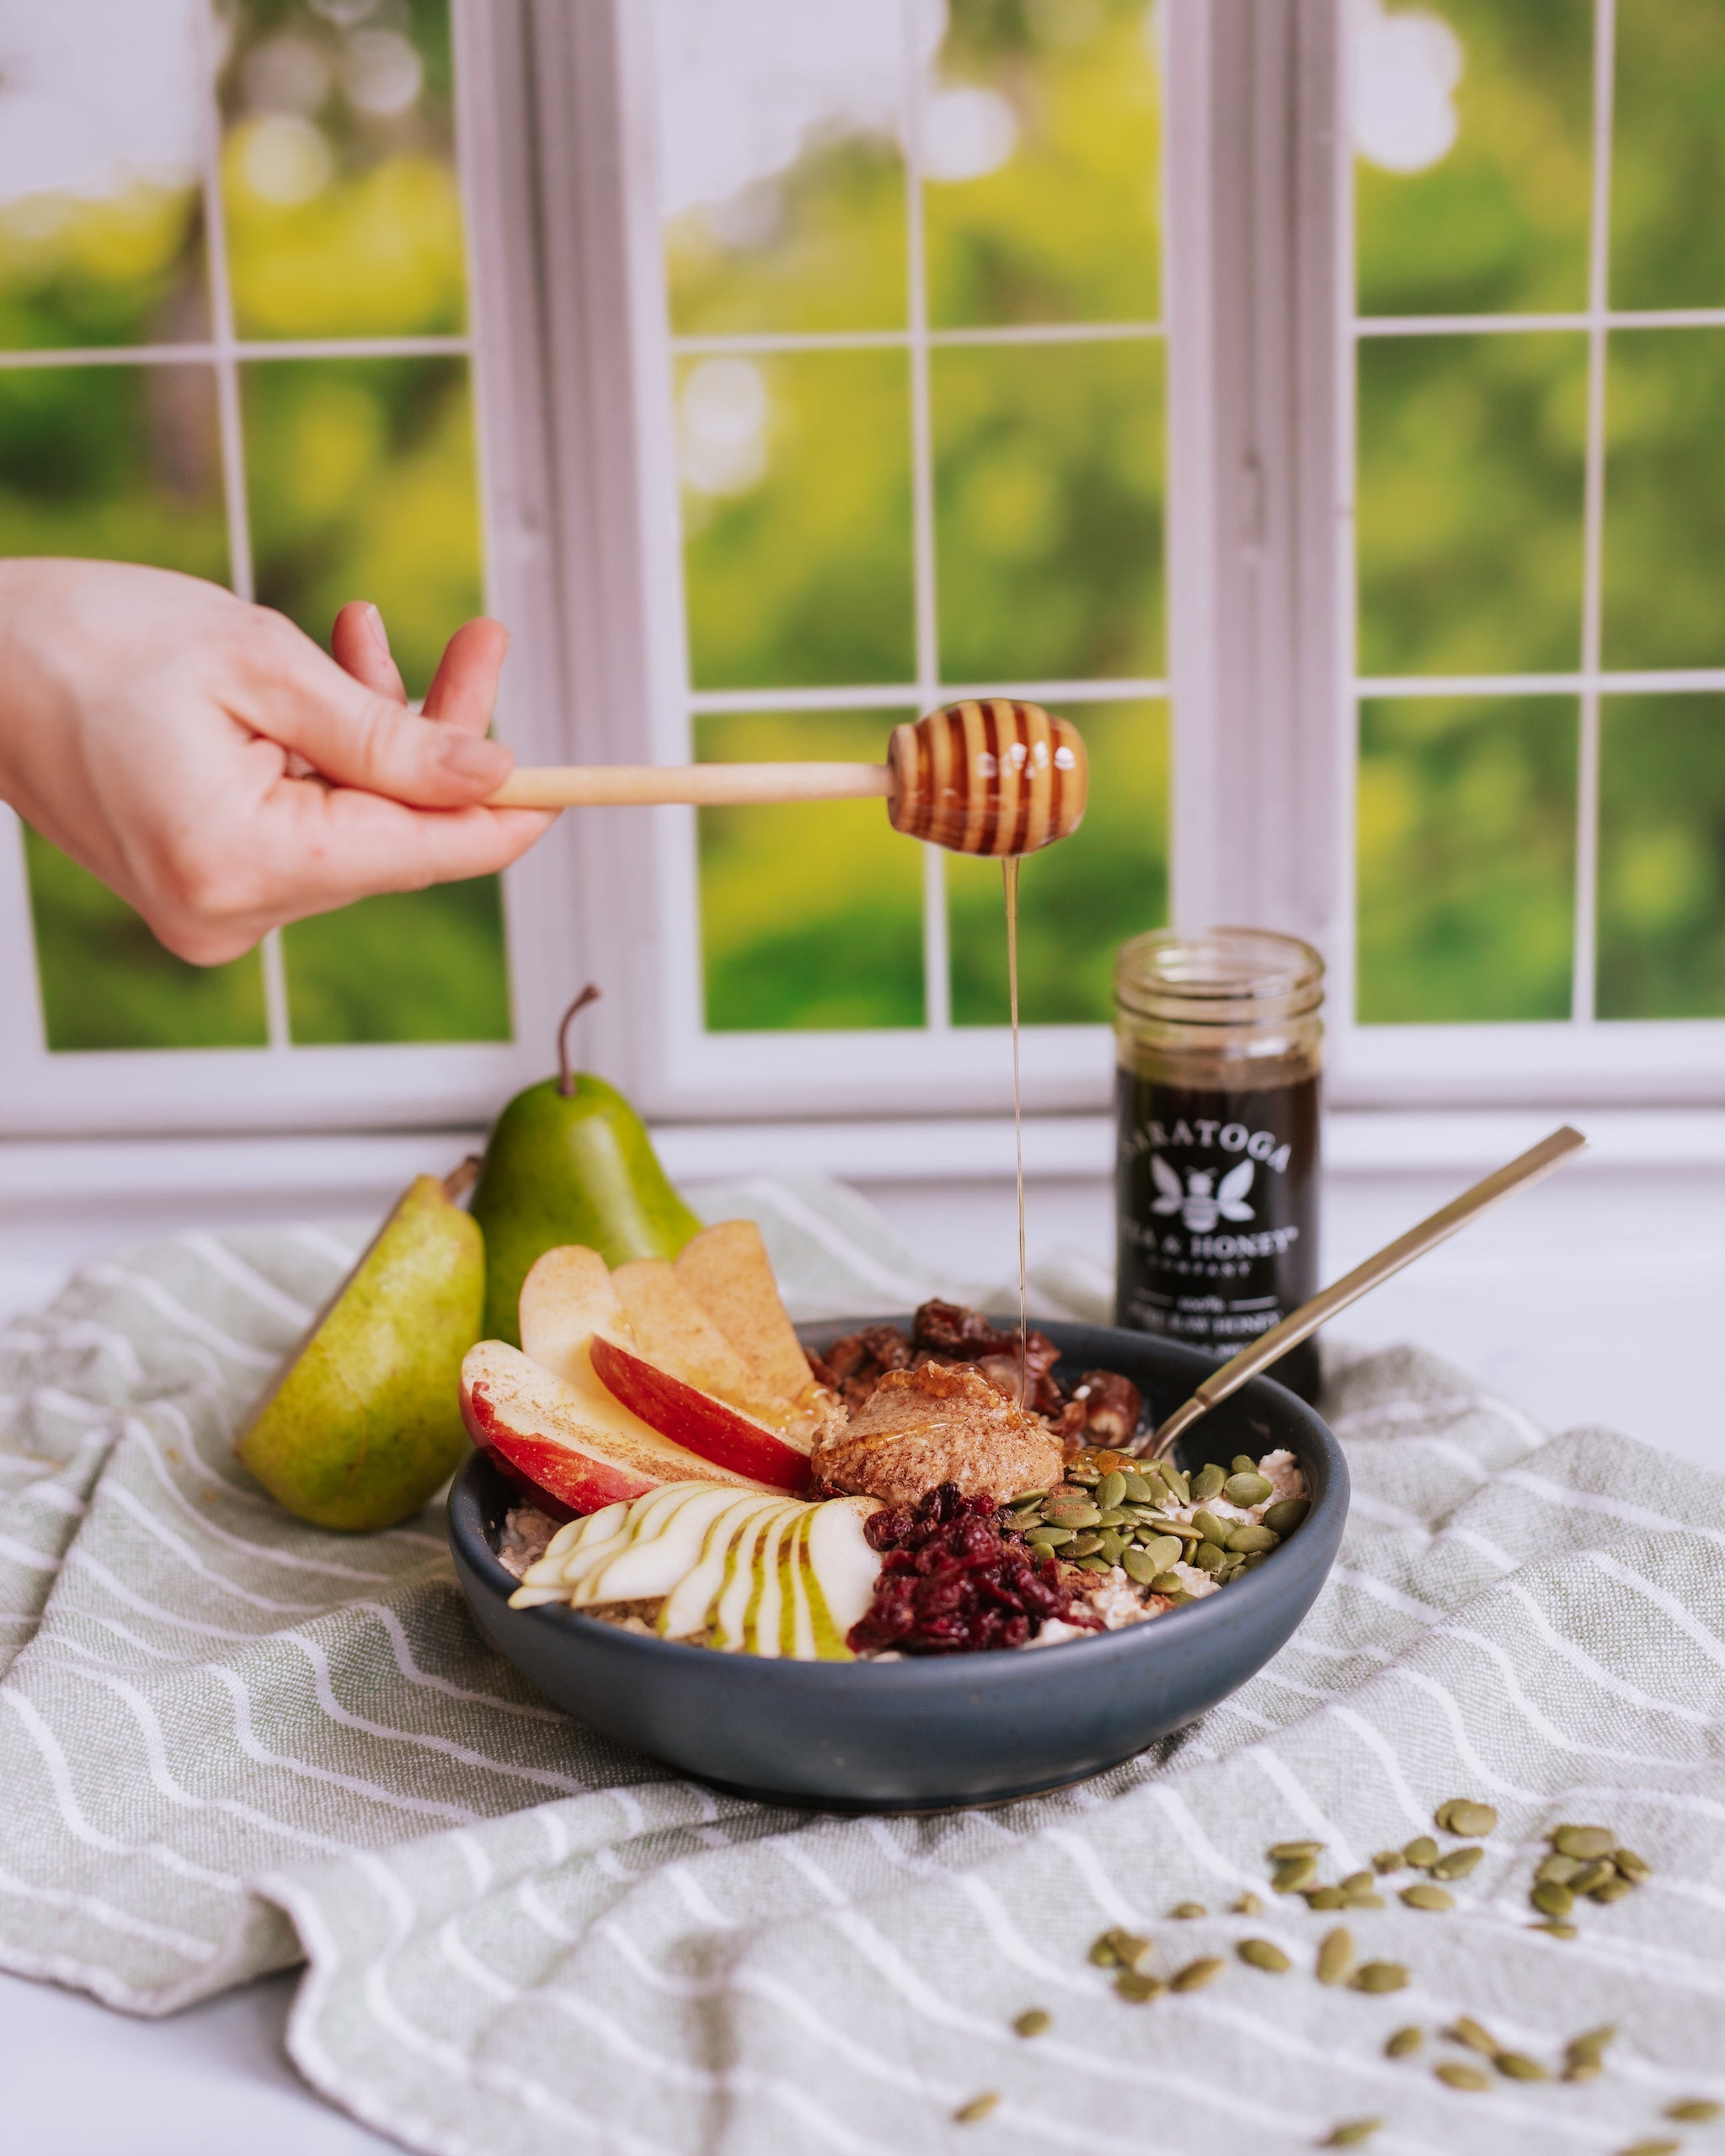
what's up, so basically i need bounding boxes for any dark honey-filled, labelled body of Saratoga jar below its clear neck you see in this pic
[1115,1070,1320,1397]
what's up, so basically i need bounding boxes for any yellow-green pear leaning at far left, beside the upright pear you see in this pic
[235,1171,485,1531]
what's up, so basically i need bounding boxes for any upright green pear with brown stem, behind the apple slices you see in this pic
[473,987,701,1348]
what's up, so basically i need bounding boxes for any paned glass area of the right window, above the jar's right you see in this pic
[1350,0,1725,1043]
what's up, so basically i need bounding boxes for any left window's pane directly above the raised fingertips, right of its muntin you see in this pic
[242,360,483,696]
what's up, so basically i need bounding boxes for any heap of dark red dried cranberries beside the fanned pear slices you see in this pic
[847,1483,1102,1654]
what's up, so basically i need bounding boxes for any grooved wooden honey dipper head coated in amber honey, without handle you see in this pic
[886,696,1089,856]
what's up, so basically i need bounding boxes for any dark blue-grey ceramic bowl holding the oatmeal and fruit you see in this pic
[448,1317,1348,1811]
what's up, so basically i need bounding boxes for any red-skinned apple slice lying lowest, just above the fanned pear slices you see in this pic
[462,1341,761,1512]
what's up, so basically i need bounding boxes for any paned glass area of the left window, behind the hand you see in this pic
[0,0,509,1052]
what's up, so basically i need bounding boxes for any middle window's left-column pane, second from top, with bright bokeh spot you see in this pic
[677,351,916,688]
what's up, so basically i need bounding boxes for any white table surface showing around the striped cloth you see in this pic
[0,1166,1725,2156]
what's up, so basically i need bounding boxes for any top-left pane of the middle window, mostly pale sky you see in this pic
[654,0,905,334]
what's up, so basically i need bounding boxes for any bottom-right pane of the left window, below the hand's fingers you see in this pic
[282,875,509,1046]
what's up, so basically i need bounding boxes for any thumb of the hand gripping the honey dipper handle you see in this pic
[238,623,515,808]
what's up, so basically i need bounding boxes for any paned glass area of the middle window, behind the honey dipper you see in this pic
[655,0,1169,1046]
